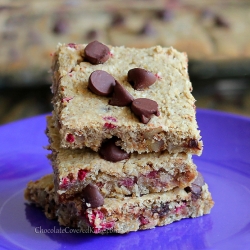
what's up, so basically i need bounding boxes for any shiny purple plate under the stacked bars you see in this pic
[0,110,250,250]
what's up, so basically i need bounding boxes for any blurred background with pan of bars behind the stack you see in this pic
[0,0,250,124]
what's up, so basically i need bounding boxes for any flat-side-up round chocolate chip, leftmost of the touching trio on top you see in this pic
[88,70,115,96]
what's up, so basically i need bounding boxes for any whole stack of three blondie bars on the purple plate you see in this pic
[25,41,213,233]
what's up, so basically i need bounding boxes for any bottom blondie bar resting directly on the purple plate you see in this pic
[25,175,214,234]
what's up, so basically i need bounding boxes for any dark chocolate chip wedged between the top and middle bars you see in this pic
[99,138,130,162]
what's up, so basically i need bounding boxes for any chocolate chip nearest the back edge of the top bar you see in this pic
[84,41,110,65]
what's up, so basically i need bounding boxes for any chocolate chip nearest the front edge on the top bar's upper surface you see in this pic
[131,98,160,124]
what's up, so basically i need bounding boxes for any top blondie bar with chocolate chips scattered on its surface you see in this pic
[52,41,202,155]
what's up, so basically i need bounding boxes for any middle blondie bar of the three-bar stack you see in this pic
[46,116,197,201]
